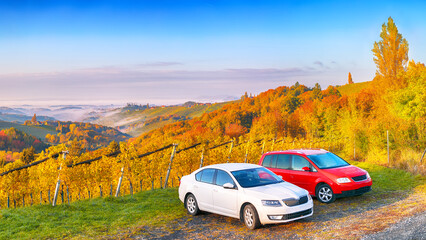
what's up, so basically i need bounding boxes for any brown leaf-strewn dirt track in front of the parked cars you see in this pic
[123,190,426,239]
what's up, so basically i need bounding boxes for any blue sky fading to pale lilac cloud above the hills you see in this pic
[0,0,426,105]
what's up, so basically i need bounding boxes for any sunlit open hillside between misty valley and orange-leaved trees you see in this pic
[93,102,232,136]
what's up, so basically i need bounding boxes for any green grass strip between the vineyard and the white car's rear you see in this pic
[0,188,185,239]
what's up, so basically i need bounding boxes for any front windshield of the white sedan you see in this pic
[232,168,283,188]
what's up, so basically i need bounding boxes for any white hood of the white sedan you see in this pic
[244,182,308,200]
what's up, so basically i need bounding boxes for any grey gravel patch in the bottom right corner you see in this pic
[362,212,426,240]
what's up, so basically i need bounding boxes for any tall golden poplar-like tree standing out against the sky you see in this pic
[372,17,408,88]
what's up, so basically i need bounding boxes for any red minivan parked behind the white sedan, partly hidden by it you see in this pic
[259,149,373,203]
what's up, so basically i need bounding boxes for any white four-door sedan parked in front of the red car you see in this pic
[179,163,313,229]
